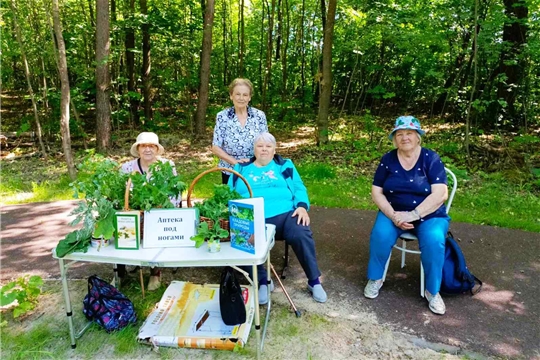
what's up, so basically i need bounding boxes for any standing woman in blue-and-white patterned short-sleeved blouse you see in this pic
[212,78,268,184]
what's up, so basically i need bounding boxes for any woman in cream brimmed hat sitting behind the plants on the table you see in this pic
[118,132,182,291]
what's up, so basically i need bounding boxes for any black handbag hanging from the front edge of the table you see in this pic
[219,266,246,325]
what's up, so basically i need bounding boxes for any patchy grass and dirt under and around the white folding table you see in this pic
[0,280,342,360]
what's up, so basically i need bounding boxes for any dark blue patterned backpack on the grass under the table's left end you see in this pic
[83,275,137,332]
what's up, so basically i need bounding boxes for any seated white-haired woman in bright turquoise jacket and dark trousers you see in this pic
[229,132,327,304]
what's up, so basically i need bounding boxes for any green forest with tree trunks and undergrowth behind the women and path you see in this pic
[0,0,540,222]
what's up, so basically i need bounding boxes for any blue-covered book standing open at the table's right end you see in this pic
[229,197,266,254]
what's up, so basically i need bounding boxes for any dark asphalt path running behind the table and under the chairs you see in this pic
[0,201,540,359]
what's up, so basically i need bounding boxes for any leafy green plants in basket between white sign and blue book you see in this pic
[191,185,242,248]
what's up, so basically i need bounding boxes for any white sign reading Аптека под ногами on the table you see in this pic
[142,208,199,249]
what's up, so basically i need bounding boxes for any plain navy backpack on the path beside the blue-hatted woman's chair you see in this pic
[441,231,482,295]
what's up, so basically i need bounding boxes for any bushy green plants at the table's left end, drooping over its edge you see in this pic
[56,154,128,257]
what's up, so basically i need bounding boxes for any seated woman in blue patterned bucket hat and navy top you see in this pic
[364,116,450,315]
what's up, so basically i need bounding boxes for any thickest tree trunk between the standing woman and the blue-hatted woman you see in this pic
[317,0,337,145]
